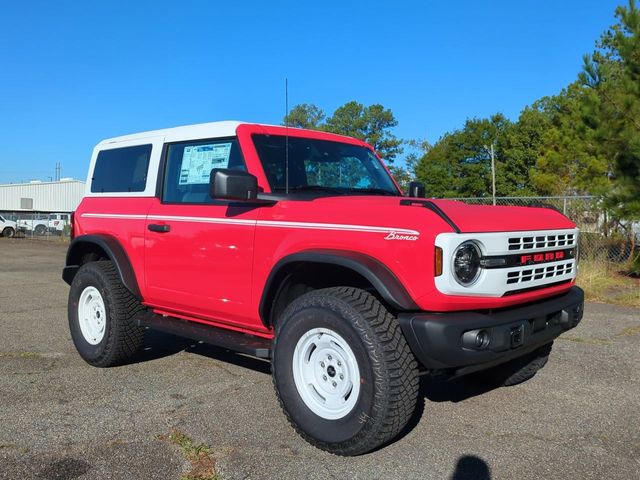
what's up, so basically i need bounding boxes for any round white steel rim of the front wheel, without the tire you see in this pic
[293,328,360,420]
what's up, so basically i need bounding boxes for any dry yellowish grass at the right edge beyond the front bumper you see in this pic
[578,259,640,307]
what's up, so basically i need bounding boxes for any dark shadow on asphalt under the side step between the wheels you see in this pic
[130,330,271,374]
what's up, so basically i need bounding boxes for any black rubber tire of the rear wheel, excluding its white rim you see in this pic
[68,261,145,367]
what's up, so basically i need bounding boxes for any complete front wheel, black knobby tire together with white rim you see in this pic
[272,287,418,455]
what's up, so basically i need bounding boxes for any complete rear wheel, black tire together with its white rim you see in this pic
[68,261,144,367]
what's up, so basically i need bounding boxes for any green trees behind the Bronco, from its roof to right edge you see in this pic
[284,0,640,220]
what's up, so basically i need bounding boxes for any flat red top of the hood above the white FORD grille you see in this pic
[430,200,575,233]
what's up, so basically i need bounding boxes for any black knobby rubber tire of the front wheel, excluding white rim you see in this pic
[272,287,419,456]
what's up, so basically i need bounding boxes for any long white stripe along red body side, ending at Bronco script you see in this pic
[81,213,420,235]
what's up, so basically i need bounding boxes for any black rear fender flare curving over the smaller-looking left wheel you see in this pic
[62,235,142,300]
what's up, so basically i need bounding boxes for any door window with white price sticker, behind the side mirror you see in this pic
[162,138,246,203]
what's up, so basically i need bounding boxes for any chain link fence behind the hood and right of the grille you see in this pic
[444,196,640,269]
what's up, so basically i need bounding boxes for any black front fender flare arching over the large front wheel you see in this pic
[259,250,418,327]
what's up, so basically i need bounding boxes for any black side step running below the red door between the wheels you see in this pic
[138,313,271,358]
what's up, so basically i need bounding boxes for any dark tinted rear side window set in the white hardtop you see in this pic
[91,145,151,193]
